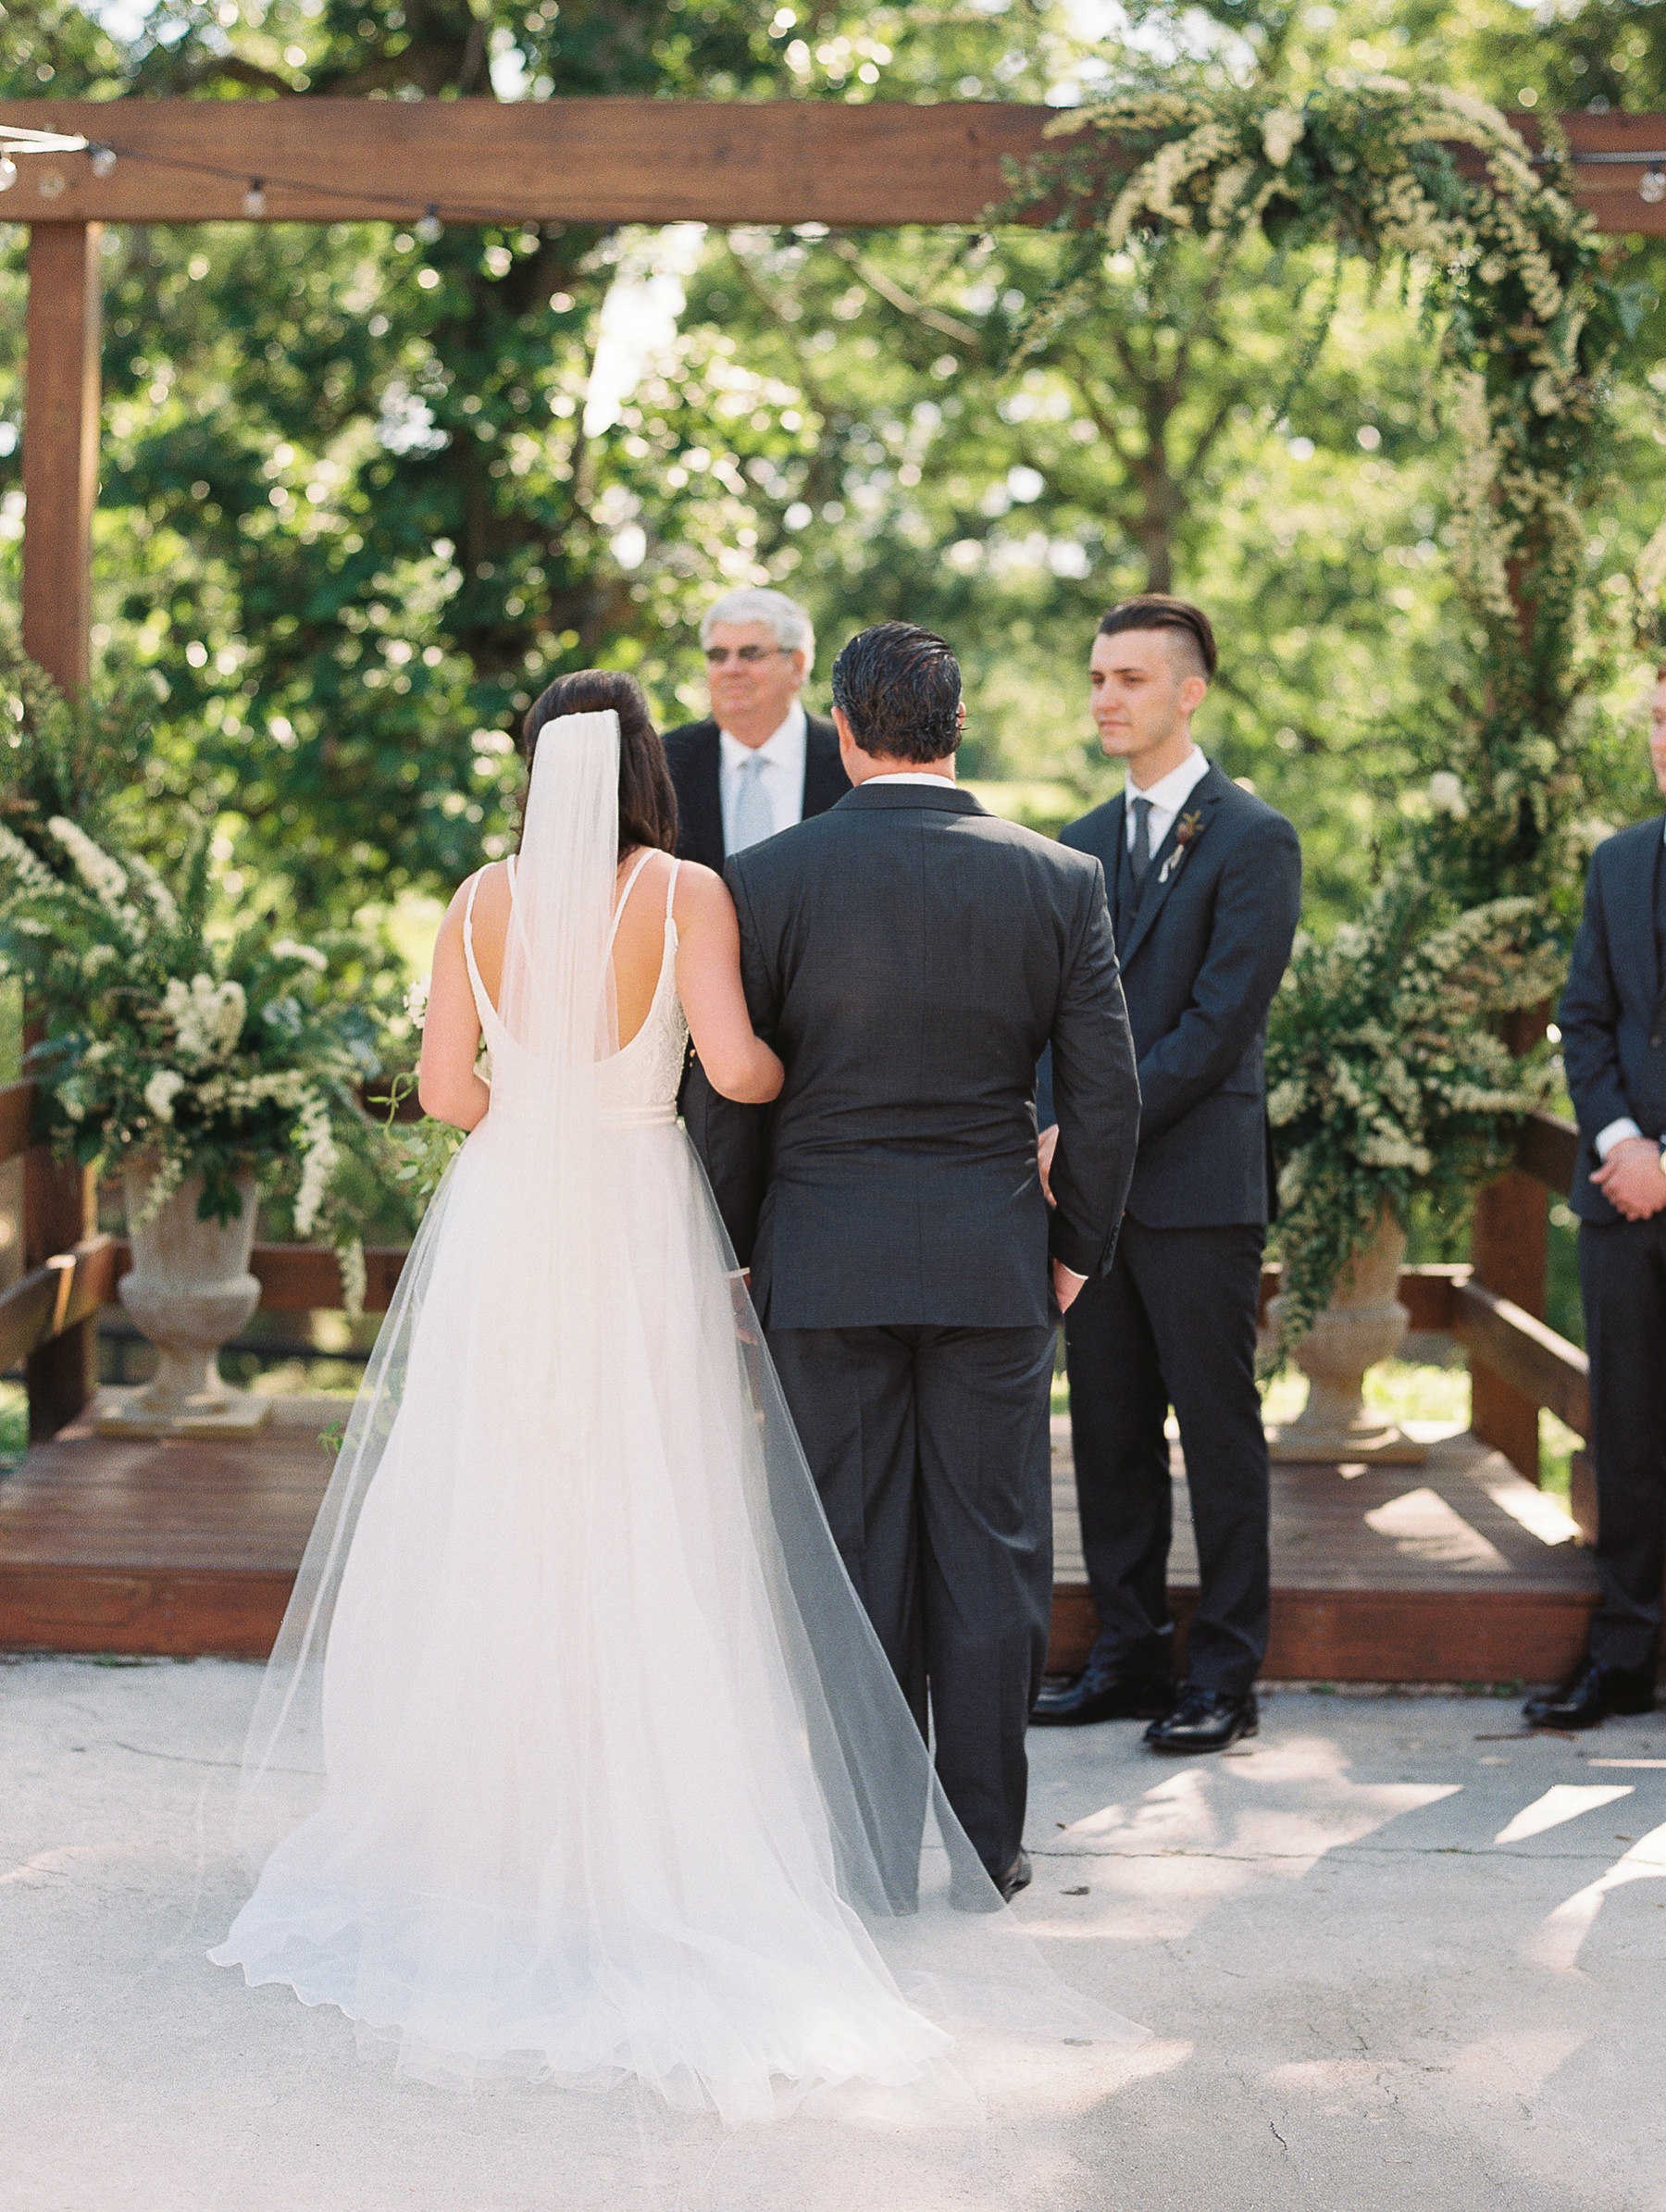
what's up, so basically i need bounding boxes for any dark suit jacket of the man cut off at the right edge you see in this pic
[1555,814,1666,1221]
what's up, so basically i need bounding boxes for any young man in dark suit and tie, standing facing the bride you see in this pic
[1036,593,1301,1752]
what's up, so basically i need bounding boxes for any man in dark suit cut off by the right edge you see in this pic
[1526,668,1666,1728]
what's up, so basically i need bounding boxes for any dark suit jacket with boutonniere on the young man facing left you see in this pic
[1038,764,1301,1230]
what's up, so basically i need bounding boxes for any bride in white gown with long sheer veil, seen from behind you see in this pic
[210,675,1139,2123]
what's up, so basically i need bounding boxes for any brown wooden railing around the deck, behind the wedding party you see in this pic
[0,1082,1591,1518]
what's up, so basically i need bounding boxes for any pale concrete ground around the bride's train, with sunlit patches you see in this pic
[0,1659,1666,2212]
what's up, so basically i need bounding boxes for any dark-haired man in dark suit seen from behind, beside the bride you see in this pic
[688,622,1139,1895]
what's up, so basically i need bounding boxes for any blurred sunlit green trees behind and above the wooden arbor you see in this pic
[0,0,1666,949]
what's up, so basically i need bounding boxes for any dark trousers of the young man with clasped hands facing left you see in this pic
[1064,1217,1273,1696]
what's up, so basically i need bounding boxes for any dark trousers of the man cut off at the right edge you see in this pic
[1580,1214,1666,1668]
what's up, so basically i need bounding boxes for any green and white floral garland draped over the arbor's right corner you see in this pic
[1013,78,1666,1358]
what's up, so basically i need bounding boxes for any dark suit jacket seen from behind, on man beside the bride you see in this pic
[686,783,1139,1329]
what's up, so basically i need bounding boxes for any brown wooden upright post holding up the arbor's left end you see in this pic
[22,223,102,1438]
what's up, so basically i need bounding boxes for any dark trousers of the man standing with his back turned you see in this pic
[767,1325,1055,1876]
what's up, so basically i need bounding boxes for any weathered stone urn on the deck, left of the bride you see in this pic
[97,1162,272,1435]
